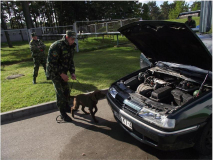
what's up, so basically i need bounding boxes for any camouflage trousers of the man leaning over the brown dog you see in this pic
[52,79,70,109]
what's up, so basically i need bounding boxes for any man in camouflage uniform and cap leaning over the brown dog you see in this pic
[46,30,76,122]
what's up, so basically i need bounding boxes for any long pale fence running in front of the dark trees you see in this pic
[1,18,139,42]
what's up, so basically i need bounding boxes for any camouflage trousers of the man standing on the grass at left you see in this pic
[33,57,46,77]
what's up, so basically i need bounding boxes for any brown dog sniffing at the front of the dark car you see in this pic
[70,90,107,123]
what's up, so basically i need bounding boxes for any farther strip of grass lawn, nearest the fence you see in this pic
[1,36,127,65]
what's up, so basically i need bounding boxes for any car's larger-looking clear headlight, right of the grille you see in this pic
[138,108,175,128]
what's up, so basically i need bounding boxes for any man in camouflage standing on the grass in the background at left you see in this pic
[30,32,46,84]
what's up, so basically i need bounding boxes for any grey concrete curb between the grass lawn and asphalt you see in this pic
[1,88,108,123]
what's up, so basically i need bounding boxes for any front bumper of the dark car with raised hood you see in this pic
[107,93,199,150]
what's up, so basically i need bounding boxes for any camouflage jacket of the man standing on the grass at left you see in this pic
[30,39,46,58]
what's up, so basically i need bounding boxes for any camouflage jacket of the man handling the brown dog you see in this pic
[46,36,76,79]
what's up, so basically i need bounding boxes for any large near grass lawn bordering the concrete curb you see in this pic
[1,45,140,112]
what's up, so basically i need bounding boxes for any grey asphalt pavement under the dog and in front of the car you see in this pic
[1,99,212,160]
